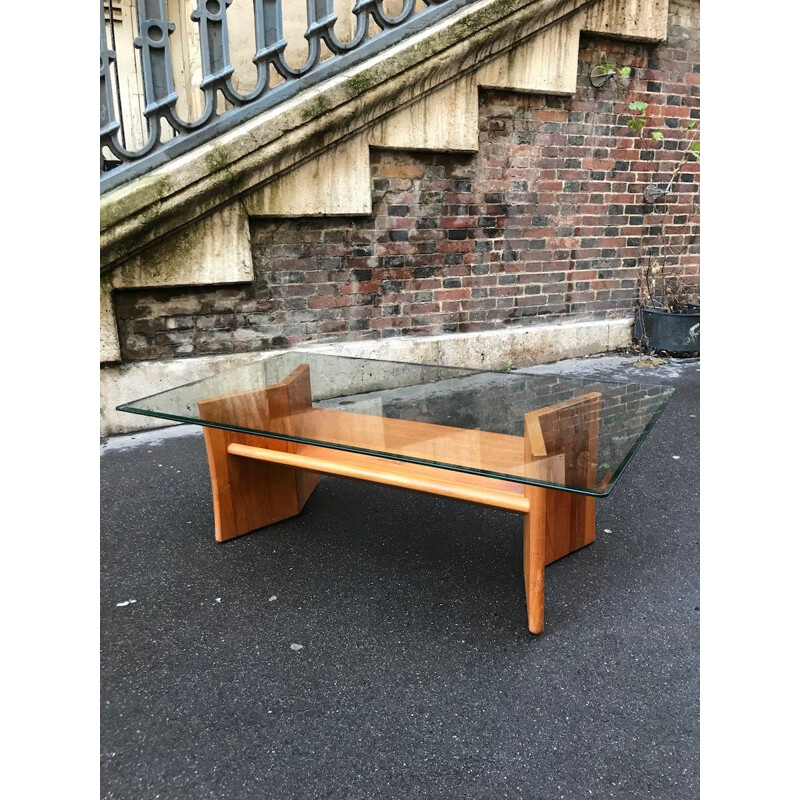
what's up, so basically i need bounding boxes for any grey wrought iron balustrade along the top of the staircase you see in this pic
[100,0,475,191]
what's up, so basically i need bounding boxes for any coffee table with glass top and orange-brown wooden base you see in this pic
[118,350,674,633]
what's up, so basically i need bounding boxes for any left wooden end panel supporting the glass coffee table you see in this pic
[198,364,317,542]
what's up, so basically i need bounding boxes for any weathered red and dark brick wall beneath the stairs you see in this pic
[115,0,700,360]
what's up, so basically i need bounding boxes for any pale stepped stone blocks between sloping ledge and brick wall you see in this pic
[100,0,669,362]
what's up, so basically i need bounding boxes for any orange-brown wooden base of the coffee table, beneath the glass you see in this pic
[200,365,600,633]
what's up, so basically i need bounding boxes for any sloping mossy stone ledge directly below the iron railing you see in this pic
[100,0,598,268]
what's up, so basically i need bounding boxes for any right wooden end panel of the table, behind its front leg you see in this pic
[525,392,601,564]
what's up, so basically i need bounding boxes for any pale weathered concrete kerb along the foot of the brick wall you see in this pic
[100,319,632,436]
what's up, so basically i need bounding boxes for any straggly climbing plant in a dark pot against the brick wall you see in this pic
[626,101,700,353]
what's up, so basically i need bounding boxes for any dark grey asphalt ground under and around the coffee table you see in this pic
[101,356,700,800]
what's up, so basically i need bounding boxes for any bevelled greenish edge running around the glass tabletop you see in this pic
[116,350,675,497]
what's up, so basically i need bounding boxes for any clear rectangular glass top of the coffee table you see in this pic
[118,350,674,496]
